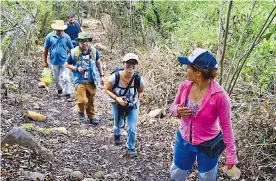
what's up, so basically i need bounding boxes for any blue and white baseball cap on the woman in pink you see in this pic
[178,48,218,70]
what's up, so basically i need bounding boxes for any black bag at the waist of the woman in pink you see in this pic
[197,132,226,158]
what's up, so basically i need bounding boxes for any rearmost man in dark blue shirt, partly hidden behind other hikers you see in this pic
[64,13,83,47]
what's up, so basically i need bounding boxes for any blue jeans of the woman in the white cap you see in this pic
[112,102,140,149]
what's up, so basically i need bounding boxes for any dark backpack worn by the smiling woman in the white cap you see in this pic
[111,67,141,97]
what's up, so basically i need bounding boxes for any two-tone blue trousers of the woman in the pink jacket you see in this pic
[170,131,218,181]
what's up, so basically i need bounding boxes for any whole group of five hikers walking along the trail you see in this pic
[43,13,238,181]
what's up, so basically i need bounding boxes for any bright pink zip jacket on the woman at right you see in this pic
[170,80,238,164]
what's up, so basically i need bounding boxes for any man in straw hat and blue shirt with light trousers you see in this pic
[43,20,74,101]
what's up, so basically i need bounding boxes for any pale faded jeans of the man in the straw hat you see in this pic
[52,65,71,94]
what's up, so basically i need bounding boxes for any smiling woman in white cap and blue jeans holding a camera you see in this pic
[105,53,145,157]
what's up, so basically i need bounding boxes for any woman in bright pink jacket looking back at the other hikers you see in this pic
[170,48,238,181]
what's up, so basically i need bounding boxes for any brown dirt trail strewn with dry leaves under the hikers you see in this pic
[1,20,177,181]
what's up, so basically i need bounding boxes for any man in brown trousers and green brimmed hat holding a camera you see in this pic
[66,32,104,125]
